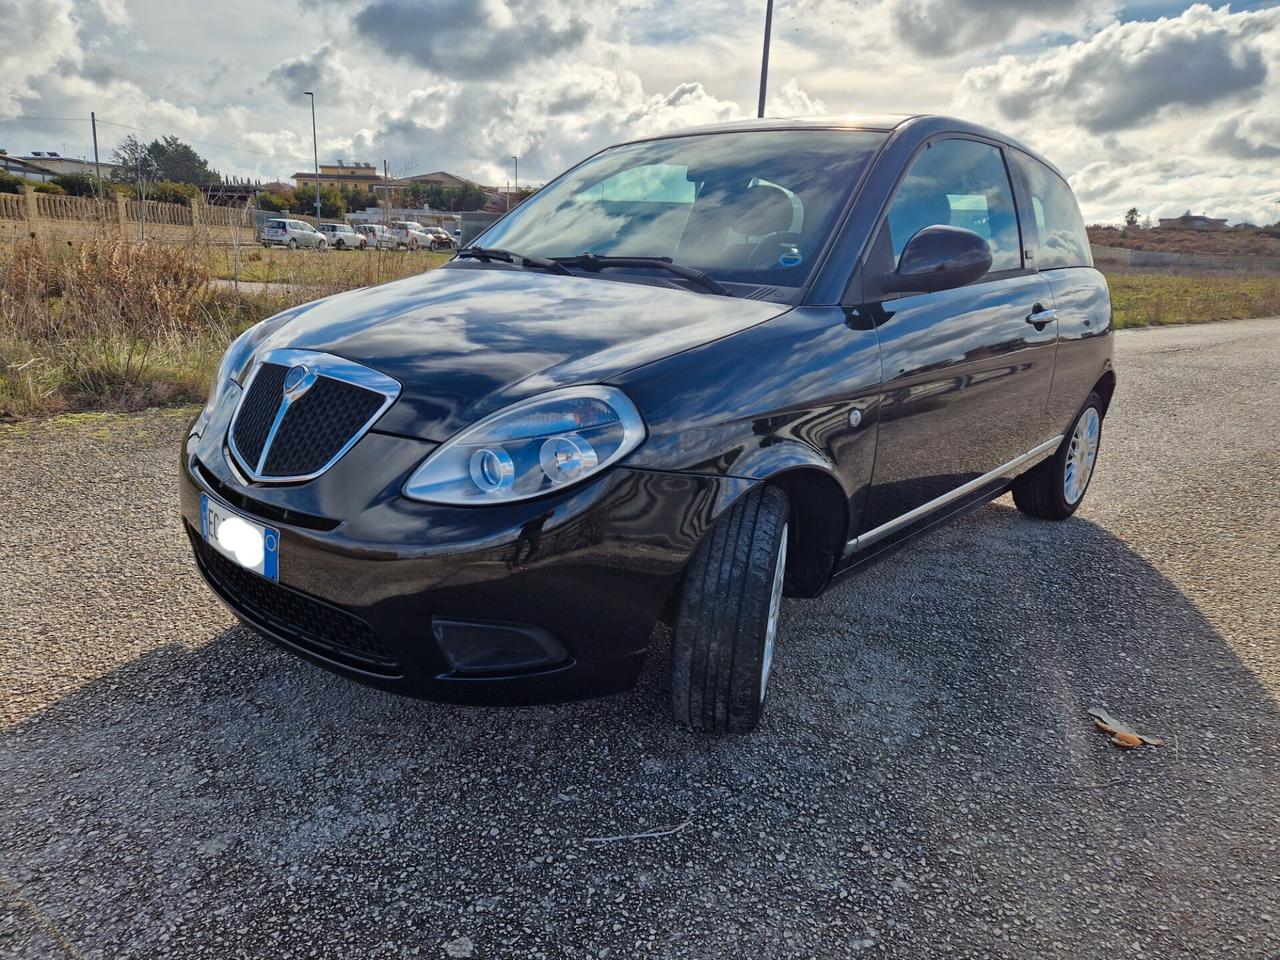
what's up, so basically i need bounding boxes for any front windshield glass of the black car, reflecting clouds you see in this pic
[475,131,884,287]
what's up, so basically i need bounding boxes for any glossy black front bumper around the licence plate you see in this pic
[180,424,749,703]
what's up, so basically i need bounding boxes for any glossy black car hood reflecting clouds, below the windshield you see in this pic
[259,265,790,440]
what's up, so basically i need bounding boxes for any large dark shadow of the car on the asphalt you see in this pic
[0,503,1280,957]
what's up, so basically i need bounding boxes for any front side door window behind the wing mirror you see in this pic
[888,140,1023,270]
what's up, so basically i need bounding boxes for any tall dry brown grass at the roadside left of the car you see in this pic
[0,238,288,419]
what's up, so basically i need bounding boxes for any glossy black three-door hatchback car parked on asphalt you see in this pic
[182,116,1115,731]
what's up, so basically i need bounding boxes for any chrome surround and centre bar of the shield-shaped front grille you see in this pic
[227,348,401,484]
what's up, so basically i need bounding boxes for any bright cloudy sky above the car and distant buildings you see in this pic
[0,0,1280,221]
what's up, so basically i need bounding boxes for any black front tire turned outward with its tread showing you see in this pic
[671,486,788,733]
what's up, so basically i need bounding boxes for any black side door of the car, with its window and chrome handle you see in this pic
[860,137,1057,544]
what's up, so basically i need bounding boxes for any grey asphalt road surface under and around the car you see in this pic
[0,321,1280,960]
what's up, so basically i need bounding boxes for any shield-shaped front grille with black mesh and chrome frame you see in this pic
[229,349,399,483]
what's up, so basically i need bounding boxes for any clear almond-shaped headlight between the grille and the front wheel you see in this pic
[404,385,644,506]
